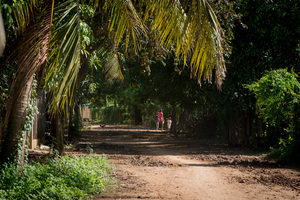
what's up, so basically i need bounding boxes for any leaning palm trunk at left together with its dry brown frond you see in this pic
[1,1,53,164]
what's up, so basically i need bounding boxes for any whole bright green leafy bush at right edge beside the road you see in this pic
[246,69,300,160]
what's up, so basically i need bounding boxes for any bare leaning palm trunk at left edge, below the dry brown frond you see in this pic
[0,76,33,165]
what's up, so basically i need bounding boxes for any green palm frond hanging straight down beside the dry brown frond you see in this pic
[45,0,81,113]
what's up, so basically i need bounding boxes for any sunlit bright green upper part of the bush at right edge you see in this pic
[246,69,300,126]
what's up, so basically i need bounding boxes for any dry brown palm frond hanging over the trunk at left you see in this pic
[8,0,53,99]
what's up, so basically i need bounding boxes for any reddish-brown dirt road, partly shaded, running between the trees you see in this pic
[77,125,300,200]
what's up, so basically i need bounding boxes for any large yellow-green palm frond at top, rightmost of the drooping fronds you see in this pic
[144,0,225,87]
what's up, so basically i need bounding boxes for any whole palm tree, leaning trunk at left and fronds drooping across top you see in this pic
[1,0,225,164]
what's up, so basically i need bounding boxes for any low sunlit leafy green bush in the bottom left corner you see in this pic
[0,155,113,200]
